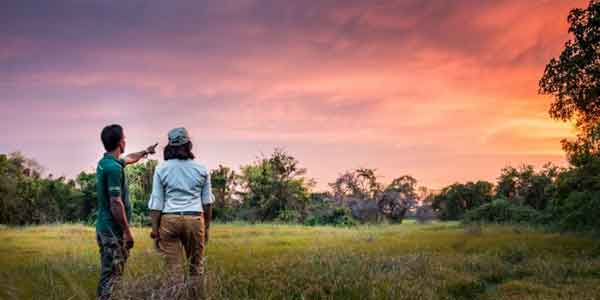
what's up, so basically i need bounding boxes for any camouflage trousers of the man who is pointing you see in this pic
[96,232,129,300]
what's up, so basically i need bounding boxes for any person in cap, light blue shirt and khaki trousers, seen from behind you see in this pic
[148,128,214,292]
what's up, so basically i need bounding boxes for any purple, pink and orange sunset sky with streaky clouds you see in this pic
[0,0,587,190]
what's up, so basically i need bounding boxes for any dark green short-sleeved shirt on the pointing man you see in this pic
[96,153,131,237]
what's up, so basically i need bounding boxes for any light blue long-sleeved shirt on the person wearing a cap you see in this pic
[148,159,214,213]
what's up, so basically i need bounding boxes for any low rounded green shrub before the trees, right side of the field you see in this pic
[463,198,545,223]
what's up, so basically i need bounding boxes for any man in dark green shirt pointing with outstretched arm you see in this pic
[96,124,158,300]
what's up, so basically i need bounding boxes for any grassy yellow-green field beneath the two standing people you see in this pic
[0,223,600,299]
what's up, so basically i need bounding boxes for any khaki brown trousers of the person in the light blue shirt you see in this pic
[158,214,204,281]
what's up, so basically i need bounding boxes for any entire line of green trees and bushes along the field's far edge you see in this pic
[0,143,600,230]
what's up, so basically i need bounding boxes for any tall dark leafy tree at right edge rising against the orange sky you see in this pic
[539,0,600,230]
